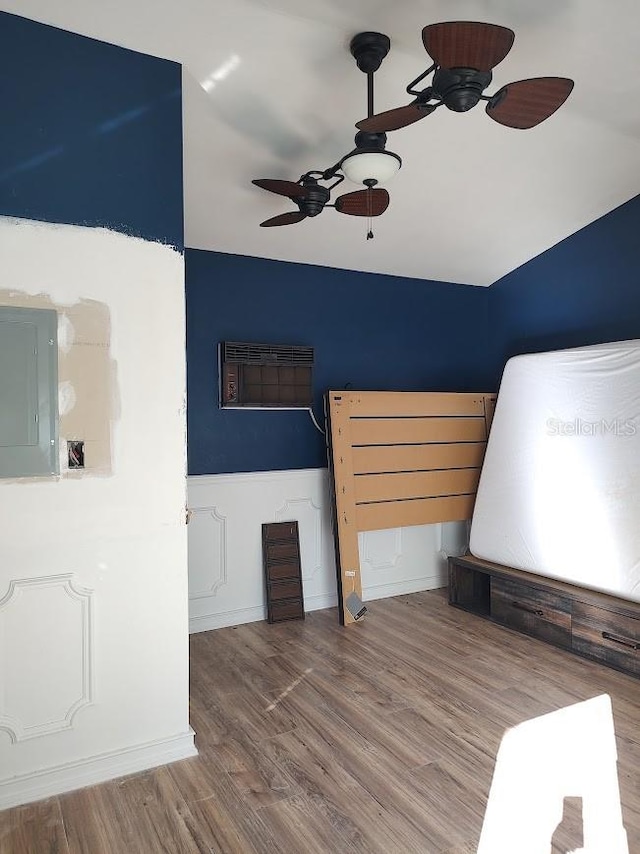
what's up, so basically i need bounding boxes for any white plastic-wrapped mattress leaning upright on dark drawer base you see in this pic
[470,340,640,602]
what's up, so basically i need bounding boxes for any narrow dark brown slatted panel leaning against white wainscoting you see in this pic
[262,522,304,623]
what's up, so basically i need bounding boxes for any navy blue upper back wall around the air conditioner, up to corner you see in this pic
[185,249,490,474]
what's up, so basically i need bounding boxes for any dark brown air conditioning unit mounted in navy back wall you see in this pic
[219,341,313,409]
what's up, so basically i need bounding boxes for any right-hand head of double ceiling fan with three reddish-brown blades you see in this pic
[356,21,573,133]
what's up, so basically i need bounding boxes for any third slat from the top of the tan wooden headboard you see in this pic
[351,442,485,475]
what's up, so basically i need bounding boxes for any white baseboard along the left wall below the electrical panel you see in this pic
[0,728,198,810]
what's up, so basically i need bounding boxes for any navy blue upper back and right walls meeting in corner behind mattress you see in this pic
[186,182,640,474]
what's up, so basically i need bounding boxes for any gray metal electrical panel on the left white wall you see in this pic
[0,306,59,477]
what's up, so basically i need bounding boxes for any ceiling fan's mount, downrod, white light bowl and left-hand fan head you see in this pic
[252,32,402,239]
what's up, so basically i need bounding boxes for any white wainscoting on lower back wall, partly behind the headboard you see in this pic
[188,469,446,632]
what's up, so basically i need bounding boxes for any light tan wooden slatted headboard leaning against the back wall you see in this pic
[326,391,496,625]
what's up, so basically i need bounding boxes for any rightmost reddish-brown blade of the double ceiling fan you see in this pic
[487,77,573,130]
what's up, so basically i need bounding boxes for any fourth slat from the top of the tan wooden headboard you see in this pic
[354,468,480,504]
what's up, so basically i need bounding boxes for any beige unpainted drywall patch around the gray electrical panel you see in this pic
[0,289,120,478]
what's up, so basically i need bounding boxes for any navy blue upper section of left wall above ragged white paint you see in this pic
[0,12,183,249]
